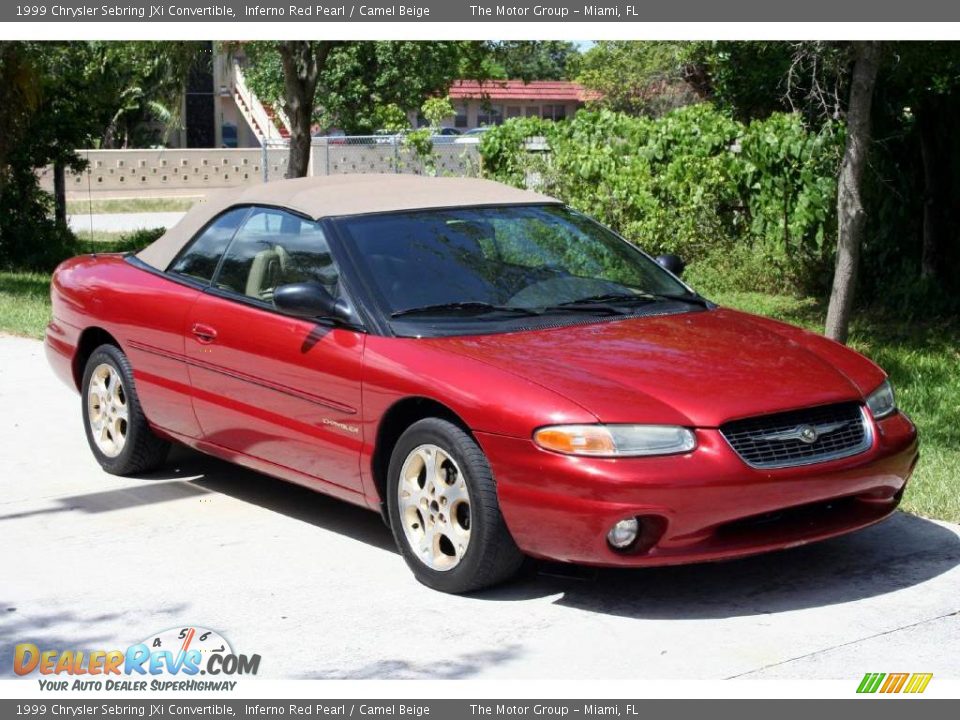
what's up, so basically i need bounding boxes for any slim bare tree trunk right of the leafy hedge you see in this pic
[826,41,880,342]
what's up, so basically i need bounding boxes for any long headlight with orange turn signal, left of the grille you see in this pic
[533,425,697,457]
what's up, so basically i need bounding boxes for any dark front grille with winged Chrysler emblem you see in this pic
[720,403,872,468]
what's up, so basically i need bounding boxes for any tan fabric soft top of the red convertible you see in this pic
[137,174,559,270]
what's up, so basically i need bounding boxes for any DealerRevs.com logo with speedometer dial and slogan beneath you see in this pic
[13,626,260,691]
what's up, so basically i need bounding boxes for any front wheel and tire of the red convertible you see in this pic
[386,418,524,593]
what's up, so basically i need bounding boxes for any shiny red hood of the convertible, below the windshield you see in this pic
[429,308,884,427]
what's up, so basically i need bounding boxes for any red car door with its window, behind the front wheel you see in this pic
[186,208,365,492]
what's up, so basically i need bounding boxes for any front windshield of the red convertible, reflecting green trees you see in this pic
[341,205,698,334]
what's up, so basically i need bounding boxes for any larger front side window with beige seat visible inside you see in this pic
[215,208,340,302]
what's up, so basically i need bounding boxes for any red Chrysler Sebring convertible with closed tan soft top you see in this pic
[46,175,918,592]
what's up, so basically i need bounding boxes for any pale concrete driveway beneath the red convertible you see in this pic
[0,337,960,681]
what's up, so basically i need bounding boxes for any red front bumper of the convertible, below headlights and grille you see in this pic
[477,413,918,566]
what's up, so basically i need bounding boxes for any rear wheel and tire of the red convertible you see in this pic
[80,345,170,475]
